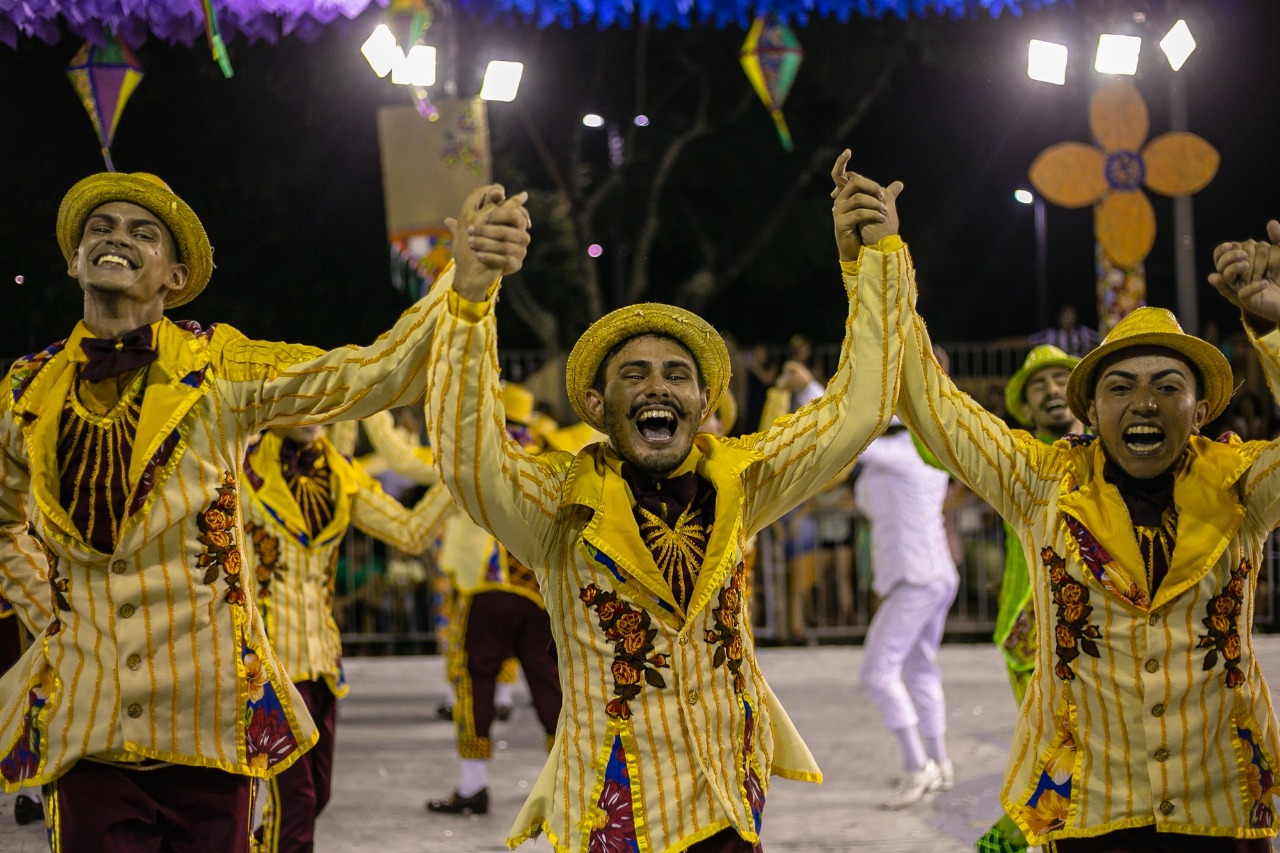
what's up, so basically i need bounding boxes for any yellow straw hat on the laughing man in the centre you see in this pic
[564,302,731,433]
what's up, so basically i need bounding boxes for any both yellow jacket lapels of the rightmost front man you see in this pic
[1057,435,1266,610]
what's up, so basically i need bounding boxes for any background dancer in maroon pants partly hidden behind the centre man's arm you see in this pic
[426,382,561,815]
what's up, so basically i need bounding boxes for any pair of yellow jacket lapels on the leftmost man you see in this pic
[13,318,210,540]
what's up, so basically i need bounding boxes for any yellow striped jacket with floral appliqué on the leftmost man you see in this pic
[0,268,452,790]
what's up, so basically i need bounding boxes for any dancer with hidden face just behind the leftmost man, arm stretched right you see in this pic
[241,424,449,853]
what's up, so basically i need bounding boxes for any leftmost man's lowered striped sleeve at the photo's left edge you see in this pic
[0,399,52,637]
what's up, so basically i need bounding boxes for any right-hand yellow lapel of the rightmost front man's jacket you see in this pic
[1152,435,1267,608]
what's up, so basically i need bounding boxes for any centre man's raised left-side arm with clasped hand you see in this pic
[426,188,572,566]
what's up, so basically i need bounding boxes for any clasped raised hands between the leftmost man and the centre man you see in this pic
[444,183,532,302]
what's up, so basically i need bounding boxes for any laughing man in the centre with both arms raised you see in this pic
[428,151,909,853]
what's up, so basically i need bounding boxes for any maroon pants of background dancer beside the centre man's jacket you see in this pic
[454,592,561,757]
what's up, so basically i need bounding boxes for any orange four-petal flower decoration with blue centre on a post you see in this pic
[1029,81,1219,268]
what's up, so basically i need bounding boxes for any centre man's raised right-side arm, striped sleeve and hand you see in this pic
[741,151,910,535]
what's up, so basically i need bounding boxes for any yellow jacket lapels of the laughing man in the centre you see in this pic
[561,433,764,624]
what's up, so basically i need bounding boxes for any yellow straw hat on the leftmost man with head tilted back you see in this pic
[58,172,214,309]
